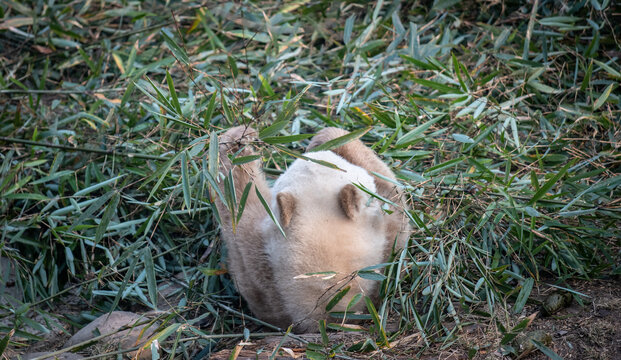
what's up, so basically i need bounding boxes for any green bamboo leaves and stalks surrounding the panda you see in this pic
[0,0,621,358]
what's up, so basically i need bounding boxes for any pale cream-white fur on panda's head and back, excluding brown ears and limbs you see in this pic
[260,151,386,328]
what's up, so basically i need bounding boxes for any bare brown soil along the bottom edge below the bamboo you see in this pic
[12,279,621,360]
